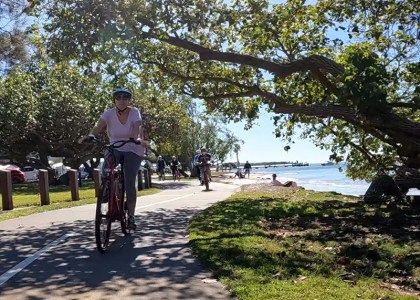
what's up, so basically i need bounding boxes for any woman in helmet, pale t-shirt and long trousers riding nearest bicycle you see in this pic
[82,88,148,229]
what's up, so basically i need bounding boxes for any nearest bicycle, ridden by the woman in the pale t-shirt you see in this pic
[84,137,137,253]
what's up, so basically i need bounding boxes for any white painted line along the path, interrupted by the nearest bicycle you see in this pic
[0,193,195,286]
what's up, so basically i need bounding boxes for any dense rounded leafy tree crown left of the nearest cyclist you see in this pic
[0,62,110,160]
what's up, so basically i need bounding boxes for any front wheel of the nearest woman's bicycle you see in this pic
[95,180,112,253]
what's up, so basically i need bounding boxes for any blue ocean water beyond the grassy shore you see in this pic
[251,164,369,196]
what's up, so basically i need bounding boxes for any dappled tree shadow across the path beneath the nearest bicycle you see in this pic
[0,209,235,300]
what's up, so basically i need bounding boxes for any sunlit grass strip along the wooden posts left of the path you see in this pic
[0,180,160,221]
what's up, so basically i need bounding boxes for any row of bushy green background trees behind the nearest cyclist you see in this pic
[0,53,240,168]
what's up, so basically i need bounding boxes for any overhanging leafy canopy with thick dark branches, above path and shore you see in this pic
[26,0,420,178]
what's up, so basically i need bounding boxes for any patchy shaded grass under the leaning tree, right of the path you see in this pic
[190,189,420,300]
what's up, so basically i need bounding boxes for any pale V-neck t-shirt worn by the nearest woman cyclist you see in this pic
[101,107,144,156]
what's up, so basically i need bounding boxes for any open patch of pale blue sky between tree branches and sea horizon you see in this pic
[226,113,331,163]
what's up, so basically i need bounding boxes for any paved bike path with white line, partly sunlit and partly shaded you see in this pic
[0,182,244,300]
